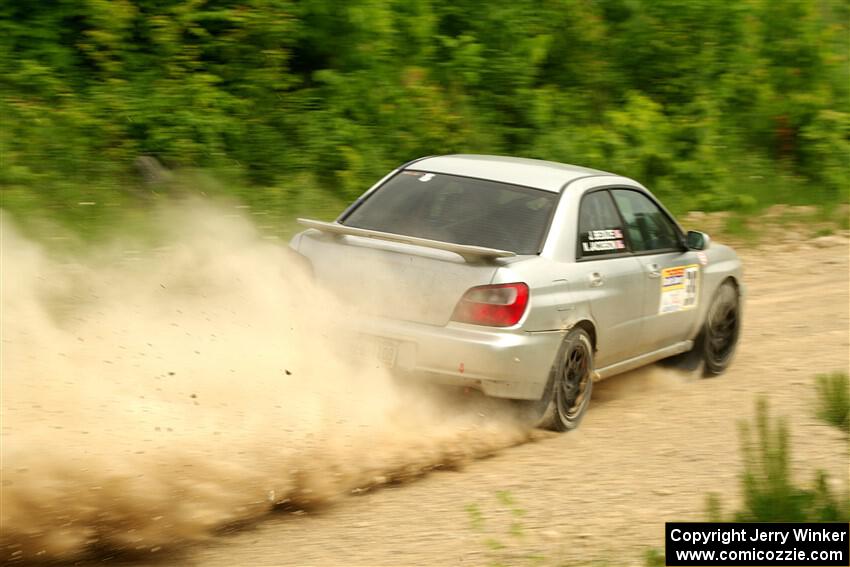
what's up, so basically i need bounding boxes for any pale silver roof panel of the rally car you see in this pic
[404,154,613,193]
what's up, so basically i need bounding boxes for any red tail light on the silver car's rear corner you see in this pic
[452,283,528,327]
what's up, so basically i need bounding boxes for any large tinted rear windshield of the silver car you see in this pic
[342,171,558,254]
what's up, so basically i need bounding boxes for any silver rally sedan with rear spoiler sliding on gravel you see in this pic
[290,155,743,431]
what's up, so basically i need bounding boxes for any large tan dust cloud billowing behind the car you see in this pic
[0,203,532,562]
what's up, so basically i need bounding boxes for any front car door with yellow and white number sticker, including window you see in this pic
[611,189,703,352]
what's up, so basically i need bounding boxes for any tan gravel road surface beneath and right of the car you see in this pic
[109,237,850,567]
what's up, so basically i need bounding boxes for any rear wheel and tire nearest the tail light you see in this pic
[529,328,593,431]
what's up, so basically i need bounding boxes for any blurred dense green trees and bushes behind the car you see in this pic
[0,0,850,222]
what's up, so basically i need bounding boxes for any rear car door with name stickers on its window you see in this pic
[575,189,646,368]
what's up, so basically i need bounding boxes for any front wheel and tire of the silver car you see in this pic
[697,281,741,376]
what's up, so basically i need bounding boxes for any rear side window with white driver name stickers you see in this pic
[578,191,627,258]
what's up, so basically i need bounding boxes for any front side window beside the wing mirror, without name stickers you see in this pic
[612,189,681,252]
